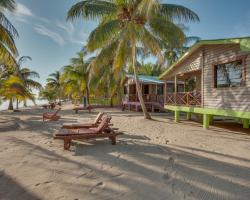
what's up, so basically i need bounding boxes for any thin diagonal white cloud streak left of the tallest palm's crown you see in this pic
[34,25,65,46]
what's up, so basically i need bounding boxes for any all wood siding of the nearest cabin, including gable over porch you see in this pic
[164,44,250,111]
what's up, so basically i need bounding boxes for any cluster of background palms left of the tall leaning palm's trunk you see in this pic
[40,50,125,106]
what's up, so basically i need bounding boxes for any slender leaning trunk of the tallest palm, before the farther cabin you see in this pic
[132,43,151,119]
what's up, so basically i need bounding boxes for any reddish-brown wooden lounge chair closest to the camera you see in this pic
[54,116,122,150]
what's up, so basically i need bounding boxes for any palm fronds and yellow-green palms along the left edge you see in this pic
[0,0,42,110]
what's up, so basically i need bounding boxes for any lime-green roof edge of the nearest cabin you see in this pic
[159,37,250,79]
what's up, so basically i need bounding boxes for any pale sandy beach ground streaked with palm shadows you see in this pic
[0,106,250,200]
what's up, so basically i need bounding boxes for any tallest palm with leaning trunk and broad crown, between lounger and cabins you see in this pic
[68,0,199,119]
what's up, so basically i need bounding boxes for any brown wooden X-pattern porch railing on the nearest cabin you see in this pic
[165,92,201,106]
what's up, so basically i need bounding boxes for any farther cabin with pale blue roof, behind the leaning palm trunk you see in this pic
[123,75,184,112]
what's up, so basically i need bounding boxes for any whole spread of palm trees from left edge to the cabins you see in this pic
[0,0,199,114]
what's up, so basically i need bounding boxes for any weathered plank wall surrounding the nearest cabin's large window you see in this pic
[204,45,250,111]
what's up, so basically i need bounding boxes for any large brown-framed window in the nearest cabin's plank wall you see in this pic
[214,59,244,88]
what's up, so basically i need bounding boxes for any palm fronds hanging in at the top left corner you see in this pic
[0,0,18,66]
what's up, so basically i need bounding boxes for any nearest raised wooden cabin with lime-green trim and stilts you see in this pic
[160,37,250,128]
